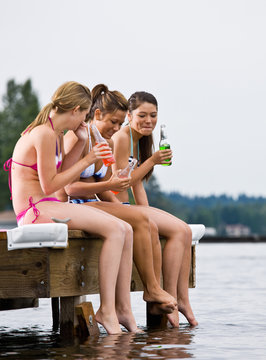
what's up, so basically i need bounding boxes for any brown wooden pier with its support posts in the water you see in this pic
[0,230,196,339]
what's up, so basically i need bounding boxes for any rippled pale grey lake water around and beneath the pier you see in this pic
[0,243,266,360]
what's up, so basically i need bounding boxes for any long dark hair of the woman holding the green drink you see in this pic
[128,91,158,181]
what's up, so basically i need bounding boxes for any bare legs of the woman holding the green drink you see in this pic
[133,206,197,327]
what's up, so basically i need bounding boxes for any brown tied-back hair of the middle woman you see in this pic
[88,84,128,120]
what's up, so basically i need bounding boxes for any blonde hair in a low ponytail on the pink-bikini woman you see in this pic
[22,81,92,135]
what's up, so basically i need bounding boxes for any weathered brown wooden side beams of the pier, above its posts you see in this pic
[0,230,196,299]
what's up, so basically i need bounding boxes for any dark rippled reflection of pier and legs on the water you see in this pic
[0,327,193,360]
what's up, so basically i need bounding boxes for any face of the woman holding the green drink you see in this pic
[128,102,157,136]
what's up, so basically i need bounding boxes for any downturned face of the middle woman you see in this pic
[95,110,126,139]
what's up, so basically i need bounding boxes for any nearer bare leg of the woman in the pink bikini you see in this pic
[24,202,131,334]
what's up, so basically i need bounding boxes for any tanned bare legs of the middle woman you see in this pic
[86,201,176,312]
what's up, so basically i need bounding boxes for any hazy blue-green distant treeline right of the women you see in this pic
[145,177,266,235]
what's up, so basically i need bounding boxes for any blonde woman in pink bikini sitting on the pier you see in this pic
[5,82,138,334]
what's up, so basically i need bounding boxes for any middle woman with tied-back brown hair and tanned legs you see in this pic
[65,84,176,329]
